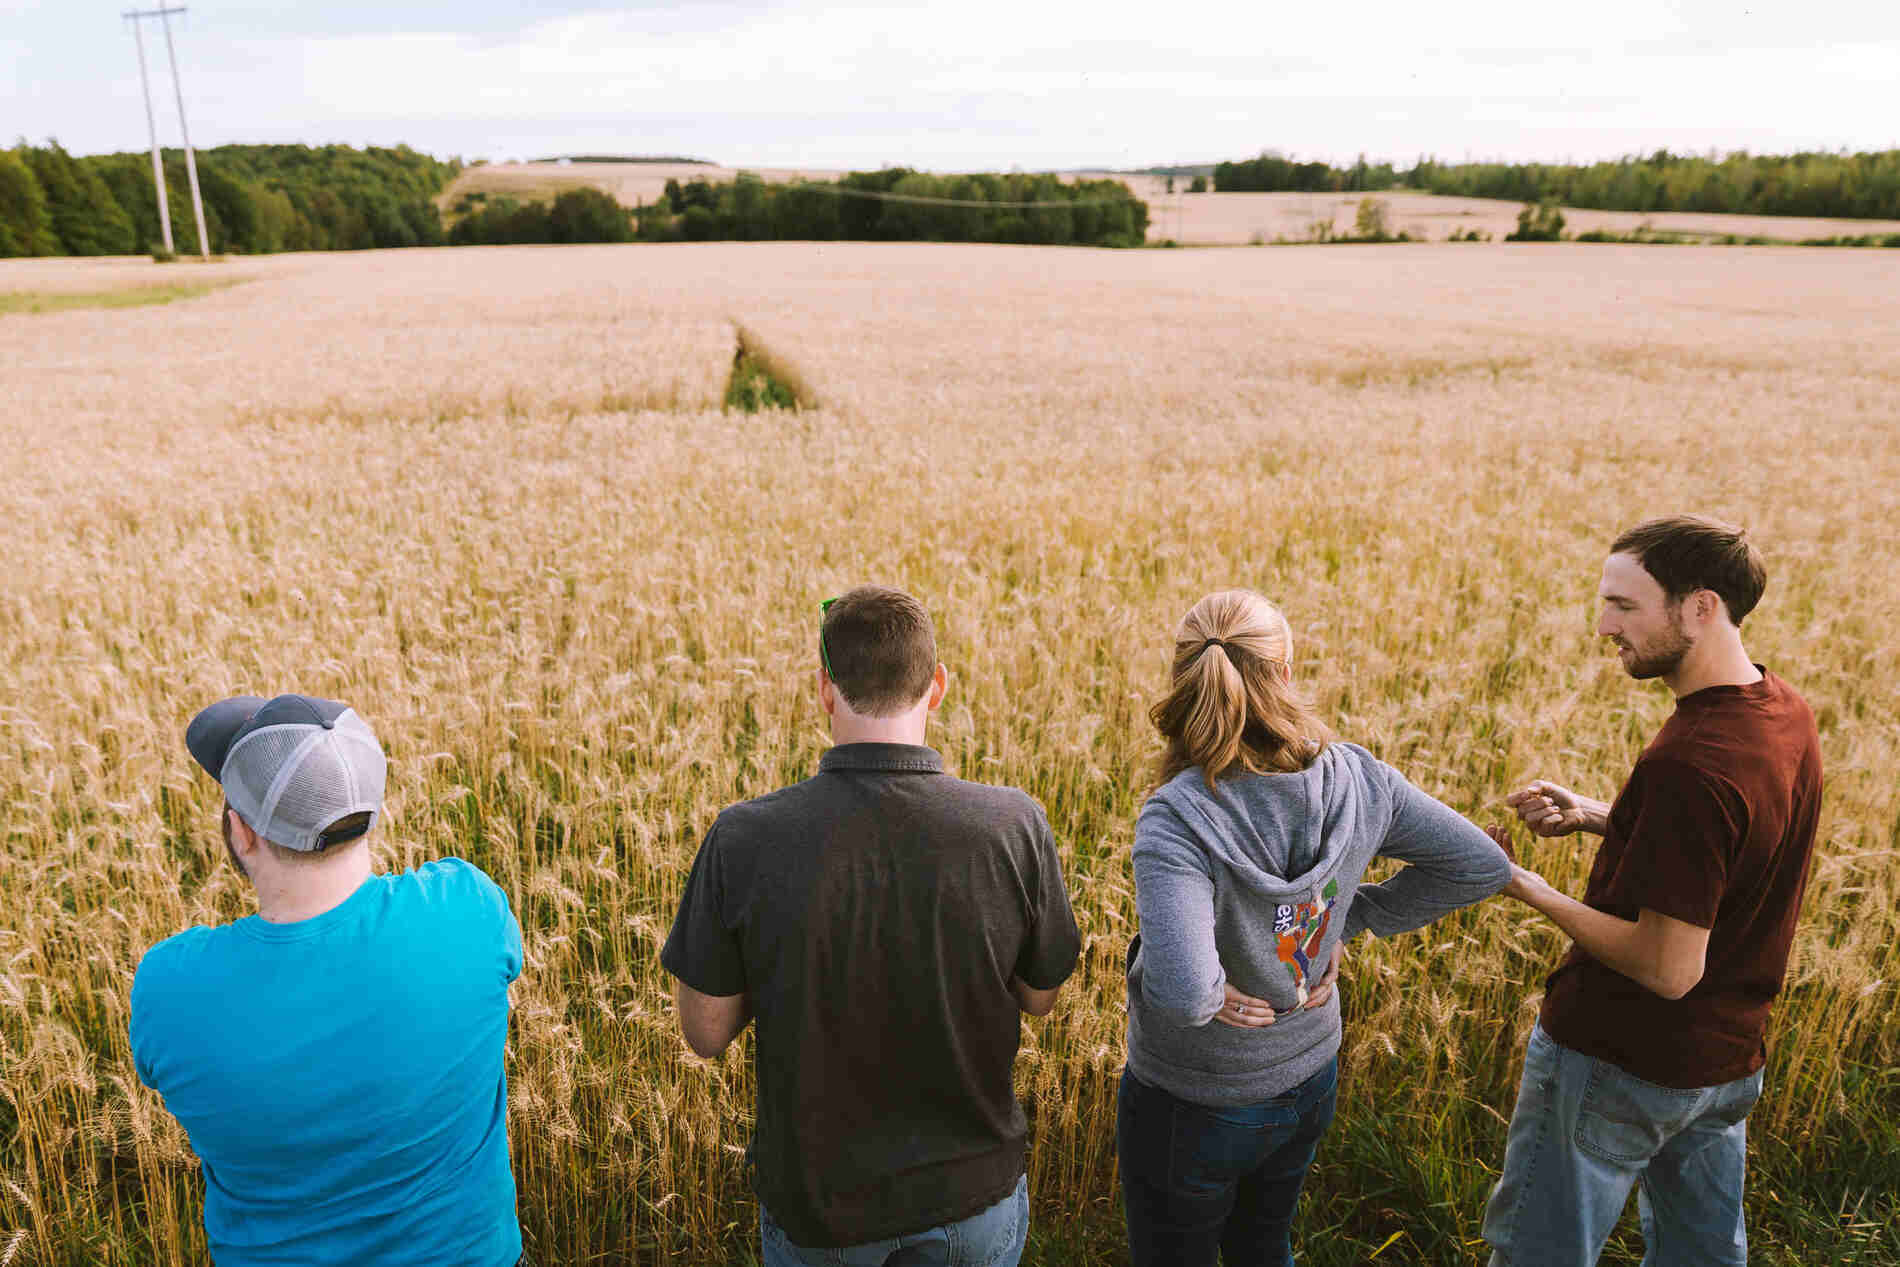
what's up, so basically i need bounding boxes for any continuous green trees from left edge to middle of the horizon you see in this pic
[0,141,1148,256]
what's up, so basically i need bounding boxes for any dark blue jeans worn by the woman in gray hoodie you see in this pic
[1115,1060,1340,1267]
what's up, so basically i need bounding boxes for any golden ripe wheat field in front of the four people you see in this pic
[0,243,1900,1267]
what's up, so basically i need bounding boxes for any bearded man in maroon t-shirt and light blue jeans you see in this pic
[1484,517,1820,1267]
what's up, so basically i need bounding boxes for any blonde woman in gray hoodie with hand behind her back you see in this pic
[1117,589,1511,1267]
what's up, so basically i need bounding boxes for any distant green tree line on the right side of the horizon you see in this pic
[1214,150,1900,220]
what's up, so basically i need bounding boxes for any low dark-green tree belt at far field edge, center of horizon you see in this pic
[635,167,1148,247]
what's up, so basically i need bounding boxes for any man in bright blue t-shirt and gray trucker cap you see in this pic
[131,695,521,1267]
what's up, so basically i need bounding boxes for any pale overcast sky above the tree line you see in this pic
[0,0,1900,171]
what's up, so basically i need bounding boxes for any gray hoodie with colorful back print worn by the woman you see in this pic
[1129,743,1511,1106]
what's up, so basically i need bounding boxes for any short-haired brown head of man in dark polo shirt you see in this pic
[819,585,937,716]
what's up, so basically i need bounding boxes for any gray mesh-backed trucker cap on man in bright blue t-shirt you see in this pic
[184,695,386,853]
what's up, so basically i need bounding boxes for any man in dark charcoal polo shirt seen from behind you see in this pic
[659,585,1079,1267]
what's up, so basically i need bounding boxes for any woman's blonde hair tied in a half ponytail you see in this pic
[1148,589,1332,788]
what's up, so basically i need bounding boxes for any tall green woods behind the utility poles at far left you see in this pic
[0,141,460,256]
